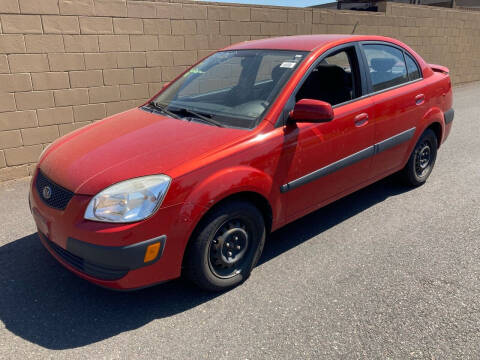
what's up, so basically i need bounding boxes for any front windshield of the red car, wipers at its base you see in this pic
[152,50,306,129]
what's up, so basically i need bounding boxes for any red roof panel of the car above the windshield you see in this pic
[224,34,396,51]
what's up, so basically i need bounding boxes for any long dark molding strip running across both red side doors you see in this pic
[280,127,416,193]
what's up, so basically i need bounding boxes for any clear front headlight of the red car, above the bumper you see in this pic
[84,175,172,223]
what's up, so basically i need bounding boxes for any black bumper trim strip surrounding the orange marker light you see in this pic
[67,235,167,270]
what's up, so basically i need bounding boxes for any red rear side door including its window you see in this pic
[361,42,426,176]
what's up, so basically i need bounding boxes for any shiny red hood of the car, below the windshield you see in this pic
[39,108,250,195]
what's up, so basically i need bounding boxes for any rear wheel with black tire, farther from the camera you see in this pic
[401,129,438,186]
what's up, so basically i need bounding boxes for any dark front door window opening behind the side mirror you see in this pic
[295,46,361,106]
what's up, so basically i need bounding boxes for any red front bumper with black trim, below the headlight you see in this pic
[29,171,205,290]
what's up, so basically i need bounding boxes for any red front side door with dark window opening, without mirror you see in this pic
[281,45,375,221]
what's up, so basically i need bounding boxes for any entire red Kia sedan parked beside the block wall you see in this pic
[29,35,454,291]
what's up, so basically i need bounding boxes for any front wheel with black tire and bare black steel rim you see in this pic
[184,200,266,291]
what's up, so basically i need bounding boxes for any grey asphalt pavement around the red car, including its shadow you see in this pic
[0,83,480,359]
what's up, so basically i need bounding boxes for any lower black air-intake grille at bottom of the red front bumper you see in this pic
[40,234,128,280]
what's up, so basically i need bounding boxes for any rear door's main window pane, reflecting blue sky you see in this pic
[363,45,408,91]
